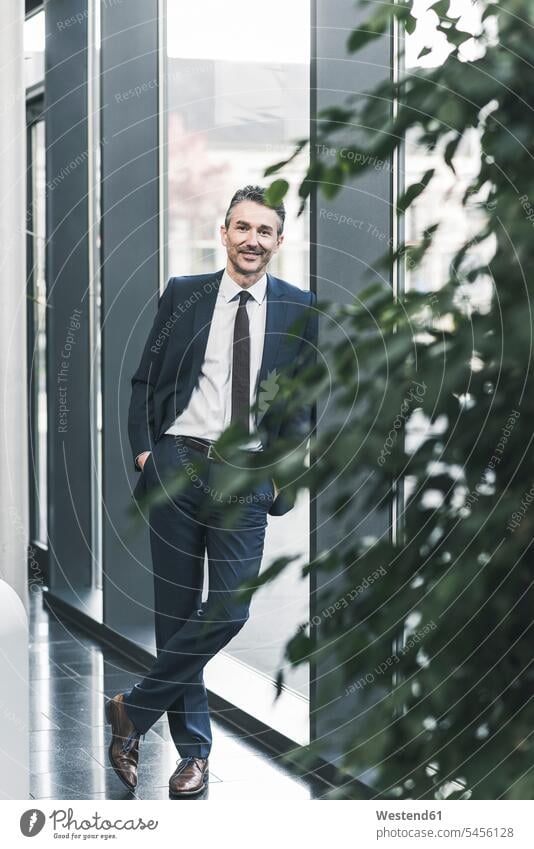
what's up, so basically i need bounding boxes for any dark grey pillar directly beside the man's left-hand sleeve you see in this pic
[101,0,159,642]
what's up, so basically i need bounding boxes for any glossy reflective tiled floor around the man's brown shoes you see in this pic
[30,592,325,800]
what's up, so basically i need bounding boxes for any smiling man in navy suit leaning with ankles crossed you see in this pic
[105,186,317,798]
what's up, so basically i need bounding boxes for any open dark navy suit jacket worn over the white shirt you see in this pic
[128,269,317,516]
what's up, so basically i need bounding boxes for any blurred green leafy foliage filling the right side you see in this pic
[256,0,534,799]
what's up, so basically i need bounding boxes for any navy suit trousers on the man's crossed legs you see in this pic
[124,434,274,758]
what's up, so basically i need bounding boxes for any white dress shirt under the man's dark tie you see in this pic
[165,270,267,451]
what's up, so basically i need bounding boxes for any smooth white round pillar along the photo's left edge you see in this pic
[0,0,29,610]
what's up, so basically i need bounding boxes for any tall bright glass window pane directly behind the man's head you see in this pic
[165,0,310,708]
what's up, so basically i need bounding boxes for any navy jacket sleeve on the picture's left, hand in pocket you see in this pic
[128,278,173,472]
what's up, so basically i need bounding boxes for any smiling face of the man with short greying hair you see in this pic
[221,200,284,279]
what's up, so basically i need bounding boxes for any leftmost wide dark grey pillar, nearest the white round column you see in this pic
[44,0,91,589]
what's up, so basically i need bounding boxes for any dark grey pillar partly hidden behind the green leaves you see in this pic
[311,0,393,778]
